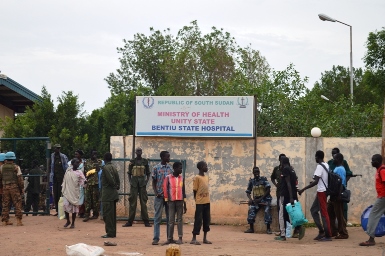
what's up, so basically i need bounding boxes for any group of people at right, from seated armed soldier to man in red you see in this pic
[245,148,385,246]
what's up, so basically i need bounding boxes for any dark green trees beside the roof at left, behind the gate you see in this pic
[1,87,88,168]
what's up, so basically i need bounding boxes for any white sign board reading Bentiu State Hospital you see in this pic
[135,96,254,137]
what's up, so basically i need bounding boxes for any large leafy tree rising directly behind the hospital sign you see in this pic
[106,21,269,96]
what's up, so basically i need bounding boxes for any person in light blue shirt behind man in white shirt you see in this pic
[328,153,349,239]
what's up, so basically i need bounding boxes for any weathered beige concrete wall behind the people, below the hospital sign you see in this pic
[111,136,381,224]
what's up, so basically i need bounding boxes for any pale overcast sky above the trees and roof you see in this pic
[0,0,385,114]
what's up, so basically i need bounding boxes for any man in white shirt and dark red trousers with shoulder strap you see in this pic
[298,150,332,241]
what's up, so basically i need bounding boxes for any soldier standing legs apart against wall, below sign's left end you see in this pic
[123,148,151,227]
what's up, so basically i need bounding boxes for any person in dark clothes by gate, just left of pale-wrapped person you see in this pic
[50,144,68,216]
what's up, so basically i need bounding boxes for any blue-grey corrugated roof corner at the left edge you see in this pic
[0,76,42,113]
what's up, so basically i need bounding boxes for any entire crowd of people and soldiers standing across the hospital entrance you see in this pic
[0,144,385,246]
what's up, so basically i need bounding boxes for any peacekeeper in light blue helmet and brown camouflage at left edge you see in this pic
[0,152,24,226]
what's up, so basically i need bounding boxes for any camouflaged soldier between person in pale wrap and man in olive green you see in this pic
[83,150,102,222]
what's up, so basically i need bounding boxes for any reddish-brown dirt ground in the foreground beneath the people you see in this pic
[0,212,385,256]
